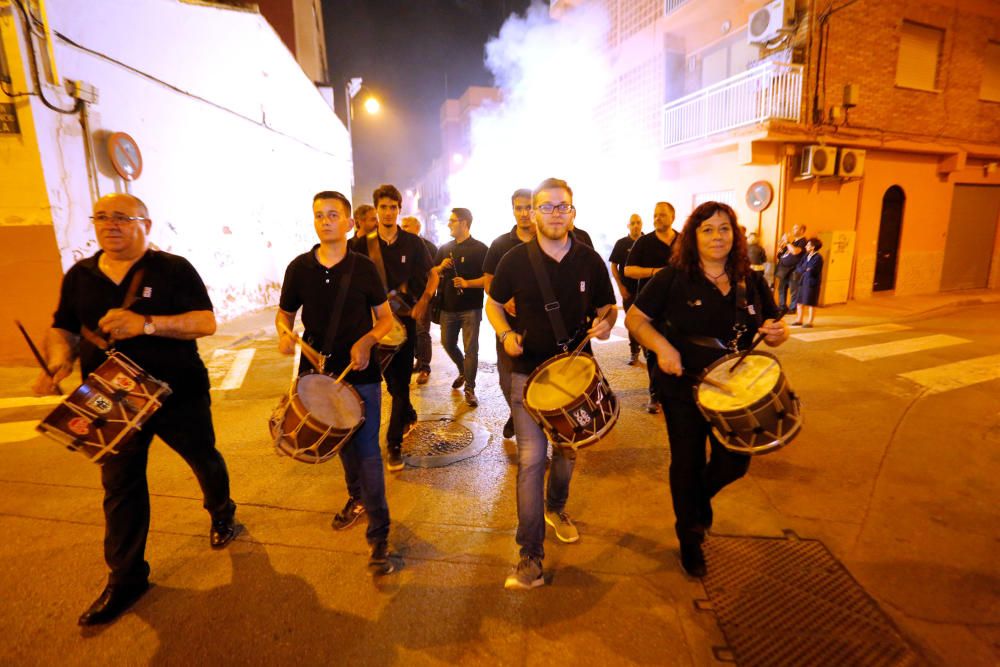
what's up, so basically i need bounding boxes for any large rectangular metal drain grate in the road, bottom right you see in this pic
[703,535,921,667]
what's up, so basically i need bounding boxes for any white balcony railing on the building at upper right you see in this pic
[663,63,802,148]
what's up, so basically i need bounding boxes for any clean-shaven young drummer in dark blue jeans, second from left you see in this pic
[275,191,395,574]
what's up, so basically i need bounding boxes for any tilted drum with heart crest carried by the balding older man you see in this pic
[36,352,171,464]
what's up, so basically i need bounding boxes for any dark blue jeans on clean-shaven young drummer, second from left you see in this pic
[340,384,389,544]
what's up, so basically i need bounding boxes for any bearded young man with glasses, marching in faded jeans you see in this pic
[486,178,617,589]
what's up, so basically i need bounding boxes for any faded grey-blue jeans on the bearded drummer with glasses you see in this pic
[510,373,575,558]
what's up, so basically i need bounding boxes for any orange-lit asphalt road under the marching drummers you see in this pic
[0,304,1000,665]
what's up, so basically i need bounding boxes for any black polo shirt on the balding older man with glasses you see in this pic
[52,250,212,395]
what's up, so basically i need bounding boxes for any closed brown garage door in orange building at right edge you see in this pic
[941,185,1000,291]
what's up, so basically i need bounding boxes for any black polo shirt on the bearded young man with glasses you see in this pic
[490,240,615,375]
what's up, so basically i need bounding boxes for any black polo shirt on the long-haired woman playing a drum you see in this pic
[635,267,778,400]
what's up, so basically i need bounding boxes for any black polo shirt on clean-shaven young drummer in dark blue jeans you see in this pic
[278,249,386,385]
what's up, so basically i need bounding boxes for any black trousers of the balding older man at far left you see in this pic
[101,392,236,584]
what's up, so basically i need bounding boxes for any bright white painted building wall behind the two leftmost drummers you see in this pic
[32,0,352,319]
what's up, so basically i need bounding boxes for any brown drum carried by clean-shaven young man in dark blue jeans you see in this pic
[268,373,365,463]
